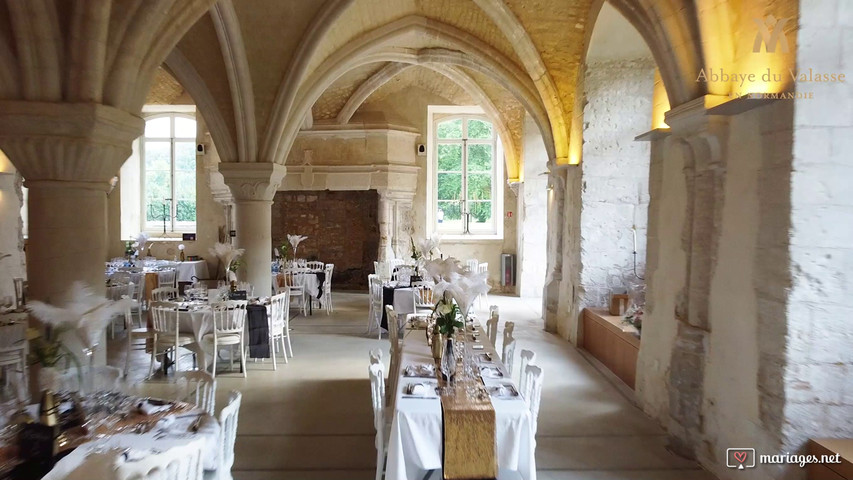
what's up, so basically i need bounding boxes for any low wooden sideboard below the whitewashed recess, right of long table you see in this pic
[581,308,640,388]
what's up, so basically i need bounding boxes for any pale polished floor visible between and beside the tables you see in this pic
[110,293,713,480]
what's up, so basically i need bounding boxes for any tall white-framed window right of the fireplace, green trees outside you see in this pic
[429,107,503,237]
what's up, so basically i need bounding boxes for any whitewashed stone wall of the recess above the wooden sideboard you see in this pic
[580,58,655,308]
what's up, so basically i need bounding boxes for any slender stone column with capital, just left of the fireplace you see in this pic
[219,162,286,297]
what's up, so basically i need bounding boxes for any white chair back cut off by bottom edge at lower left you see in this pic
[115,439,206,480]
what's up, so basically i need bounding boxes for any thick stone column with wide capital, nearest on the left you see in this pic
[0,101,144,302]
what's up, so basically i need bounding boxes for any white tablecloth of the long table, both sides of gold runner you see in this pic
[385,320,536,480]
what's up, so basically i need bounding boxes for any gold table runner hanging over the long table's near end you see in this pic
[436,366,498,480]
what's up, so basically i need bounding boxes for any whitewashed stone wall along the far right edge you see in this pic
[780,0,853,462]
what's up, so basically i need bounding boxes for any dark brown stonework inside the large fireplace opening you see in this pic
[272,190,379,291]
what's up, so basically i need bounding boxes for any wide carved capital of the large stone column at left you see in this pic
[0,100,145,184]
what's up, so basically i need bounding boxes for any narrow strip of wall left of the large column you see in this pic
[0,152,27,300]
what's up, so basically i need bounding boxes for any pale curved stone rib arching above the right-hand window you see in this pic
[337,63,521,180]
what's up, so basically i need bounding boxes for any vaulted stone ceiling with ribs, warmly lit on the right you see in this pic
[166,0,700,178]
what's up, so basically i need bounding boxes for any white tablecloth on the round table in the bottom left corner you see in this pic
[43,409,220,480]
